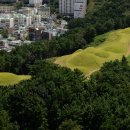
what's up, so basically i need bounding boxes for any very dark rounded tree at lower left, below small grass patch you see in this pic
[8,86,47,130]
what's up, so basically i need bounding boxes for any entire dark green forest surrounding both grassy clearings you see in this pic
[0,0,130,130]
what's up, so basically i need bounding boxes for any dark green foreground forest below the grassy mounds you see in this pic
[0,57,130,130]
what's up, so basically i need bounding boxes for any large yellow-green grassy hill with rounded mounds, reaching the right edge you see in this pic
[54,28,130,76]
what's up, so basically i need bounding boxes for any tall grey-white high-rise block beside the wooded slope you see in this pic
[59,0,87,18]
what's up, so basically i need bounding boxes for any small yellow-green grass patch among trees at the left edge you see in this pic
[0,72,31,86]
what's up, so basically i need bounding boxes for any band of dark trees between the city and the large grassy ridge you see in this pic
[0,0,130,74]
